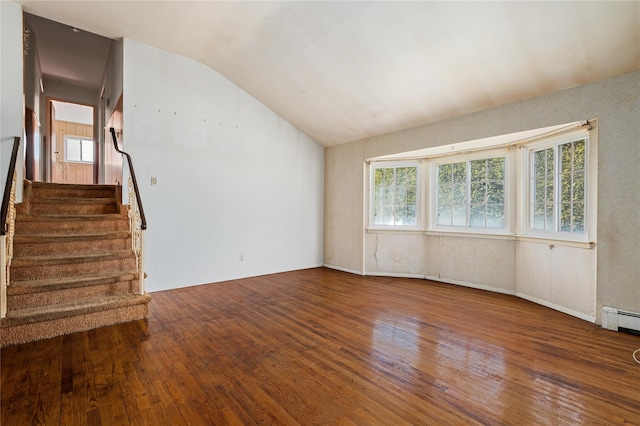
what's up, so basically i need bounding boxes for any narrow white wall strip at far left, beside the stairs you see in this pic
[0,1,24,201]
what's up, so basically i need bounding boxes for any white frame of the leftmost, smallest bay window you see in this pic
[367,159,424,231]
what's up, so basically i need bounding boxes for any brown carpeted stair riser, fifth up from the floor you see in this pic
[16,217,129,235]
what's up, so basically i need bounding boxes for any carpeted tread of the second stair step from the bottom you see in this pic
[7,270,138,295]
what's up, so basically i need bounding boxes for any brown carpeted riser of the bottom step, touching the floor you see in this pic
[0,294,150,347]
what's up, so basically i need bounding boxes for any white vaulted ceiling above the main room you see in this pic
[17,0,640,146]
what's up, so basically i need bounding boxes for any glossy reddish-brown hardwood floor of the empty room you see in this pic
[1,268,640,426]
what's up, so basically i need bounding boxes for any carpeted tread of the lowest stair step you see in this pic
[0,293,151,328]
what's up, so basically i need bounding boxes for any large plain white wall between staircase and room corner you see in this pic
[123,40,324,291]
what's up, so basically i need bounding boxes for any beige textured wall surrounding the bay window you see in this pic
[324,72,640,322]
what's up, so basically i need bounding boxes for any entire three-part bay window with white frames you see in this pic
[368,119,598,247]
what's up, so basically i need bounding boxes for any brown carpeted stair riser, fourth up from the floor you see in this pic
[13,238,131,257]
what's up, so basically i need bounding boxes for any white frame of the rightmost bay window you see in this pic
[522,129,593,242]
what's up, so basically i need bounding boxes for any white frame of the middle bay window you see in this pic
[428,147,512,235]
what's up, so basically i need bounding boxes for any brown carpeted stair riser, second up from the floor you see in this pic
[7,280,140,312]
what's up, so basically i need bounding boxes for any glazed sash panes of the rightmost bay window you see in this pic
[530,138,587,234]
